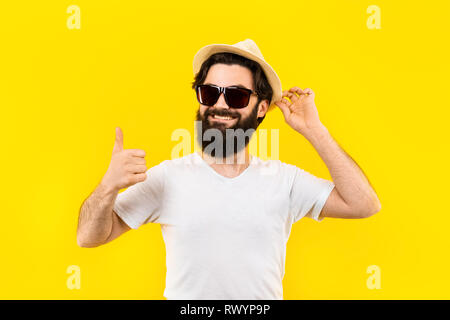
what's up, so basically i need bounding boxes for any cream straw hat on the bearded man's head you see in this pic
[193,39,282,111]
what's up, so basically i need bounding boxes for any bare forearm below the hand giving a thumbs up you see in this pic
[77,183,118,247]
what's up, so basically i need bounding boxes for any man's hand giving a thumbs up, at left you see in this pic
[101,127,147,192]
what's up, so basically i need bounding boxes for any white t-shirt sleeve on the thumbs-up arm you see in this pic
[113,161,166,229]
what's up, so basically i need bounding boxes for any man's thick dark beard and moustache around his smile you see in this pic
[196,103,259,159]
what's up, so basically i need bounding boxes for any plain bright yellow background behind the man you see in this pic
[0,0,450,299]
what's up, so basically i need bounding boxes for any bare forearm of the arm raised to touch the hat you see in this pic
[305,126,381,213]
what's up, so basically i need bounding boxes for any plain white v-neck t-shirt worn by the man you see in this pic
[114,152,334,300]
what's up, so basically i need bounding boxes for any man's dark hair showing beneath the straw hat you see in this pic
[192,52,273,125]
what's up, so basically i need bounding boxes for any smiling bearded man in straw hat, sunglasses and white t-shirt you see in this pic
[77,39,381,299]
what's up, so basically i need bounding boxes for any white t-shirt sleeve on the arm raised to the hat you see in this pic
[288,165,335,222]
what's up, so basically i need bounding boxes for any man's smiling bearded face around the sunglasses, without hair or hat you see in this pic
[196,63,267,156]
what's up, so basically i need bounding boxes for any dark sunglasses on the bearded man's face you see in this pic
[195,84,258,109]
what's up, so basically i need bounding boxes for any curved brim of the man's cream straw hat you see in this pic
[193,44,282,112]
